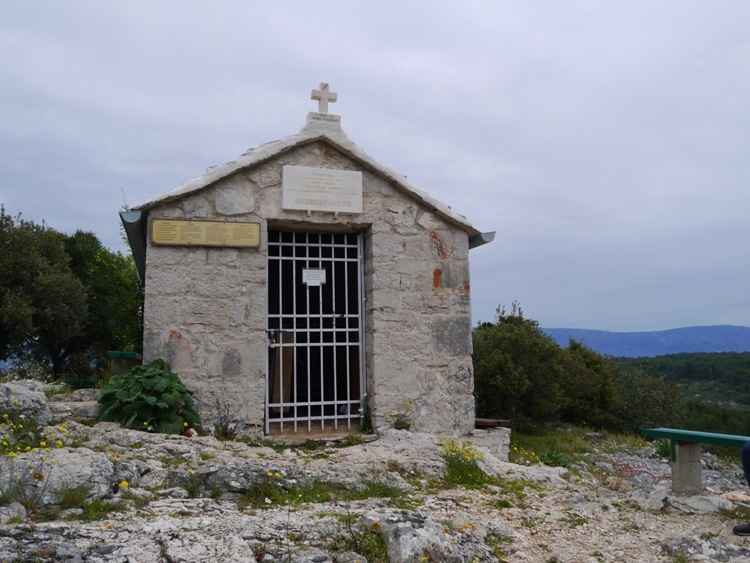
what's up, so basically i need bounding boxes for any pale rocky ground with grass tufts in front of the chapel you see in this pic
[0,382,750,563]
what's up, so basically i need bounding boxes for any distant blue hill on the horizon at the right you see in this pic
[542,325,750,358]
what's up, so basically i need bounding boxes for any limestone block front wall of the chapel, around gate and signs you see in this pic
[144,141,474,434]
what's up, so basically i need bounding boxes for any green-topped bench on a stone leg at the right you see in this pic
[641,428,750,493]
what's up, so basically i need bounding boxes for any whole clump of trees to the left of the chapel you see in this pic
[0,209,143,379]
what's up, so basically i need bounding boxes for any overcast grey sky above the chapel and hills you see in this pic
[0,0,750,331]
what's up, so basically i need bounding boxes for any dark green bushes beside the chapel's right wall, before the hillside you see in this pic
[472,303,683,432]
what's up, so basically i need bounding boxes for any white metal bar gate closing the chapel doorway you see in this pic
[265,231,365,434]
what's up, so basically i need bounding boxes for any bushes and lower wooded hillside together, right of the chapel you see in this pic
[482,303,750,436]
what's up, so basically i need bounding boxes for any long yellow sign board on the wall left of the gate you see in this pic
[151,219,260,248]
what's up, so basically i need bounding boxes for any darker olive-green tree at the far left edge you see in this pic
[0,206,88,377]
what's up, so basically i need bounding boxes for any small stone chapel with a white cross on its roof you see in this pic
[121,84,494,439]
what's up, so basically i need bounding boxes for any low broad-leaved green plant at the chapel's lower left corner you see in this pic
[99,360,200,434]
